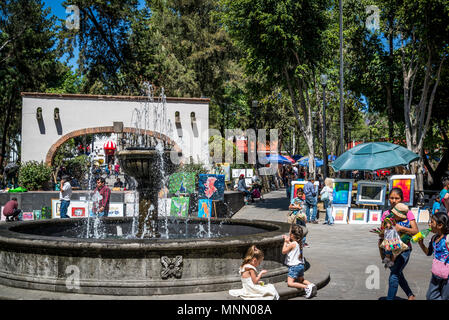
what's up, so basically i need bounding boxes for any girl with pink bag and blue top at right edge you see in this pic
[418,212,449,300]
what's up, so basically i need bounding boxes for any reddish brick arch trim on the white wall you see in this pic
[45,126,181,166]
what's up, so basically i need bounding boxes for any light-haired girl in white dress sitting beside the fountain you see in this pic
[229,245,279,300]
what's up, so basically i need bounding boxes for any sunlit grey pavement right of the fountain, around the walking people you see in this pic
[233,189,432,300]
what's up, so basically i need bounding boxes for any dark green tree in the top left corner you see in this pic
[0,0,62,171]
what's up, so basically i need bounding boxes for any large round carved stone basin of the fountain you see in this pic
[0,217,296,295]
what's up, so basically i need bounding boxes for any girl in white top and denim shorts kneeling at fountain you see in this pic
[282,225,317,299]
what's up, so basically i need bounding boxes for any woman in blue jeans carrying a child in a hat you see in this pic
[379,188,419,300]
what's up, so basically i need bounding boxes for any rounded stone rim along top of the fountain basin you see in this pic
[0,217,294,256]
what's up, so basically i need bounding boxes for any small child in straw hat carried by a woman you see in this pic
[381,203,410,268]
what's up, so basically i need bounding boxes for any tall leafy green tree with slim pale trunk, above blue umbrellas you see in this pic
[221,0,329,176]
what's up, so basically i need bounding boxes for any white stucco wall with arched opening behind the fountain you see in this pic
[21,92,209,164]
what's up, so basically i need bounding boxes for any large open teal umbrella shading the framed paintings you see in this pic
[331,142,419,171]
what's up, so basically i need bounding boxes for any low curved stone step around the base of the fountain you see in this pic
[0,259,330,300]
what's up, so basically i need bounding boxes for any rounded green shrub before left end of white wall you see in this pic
[19,161,52,191]
